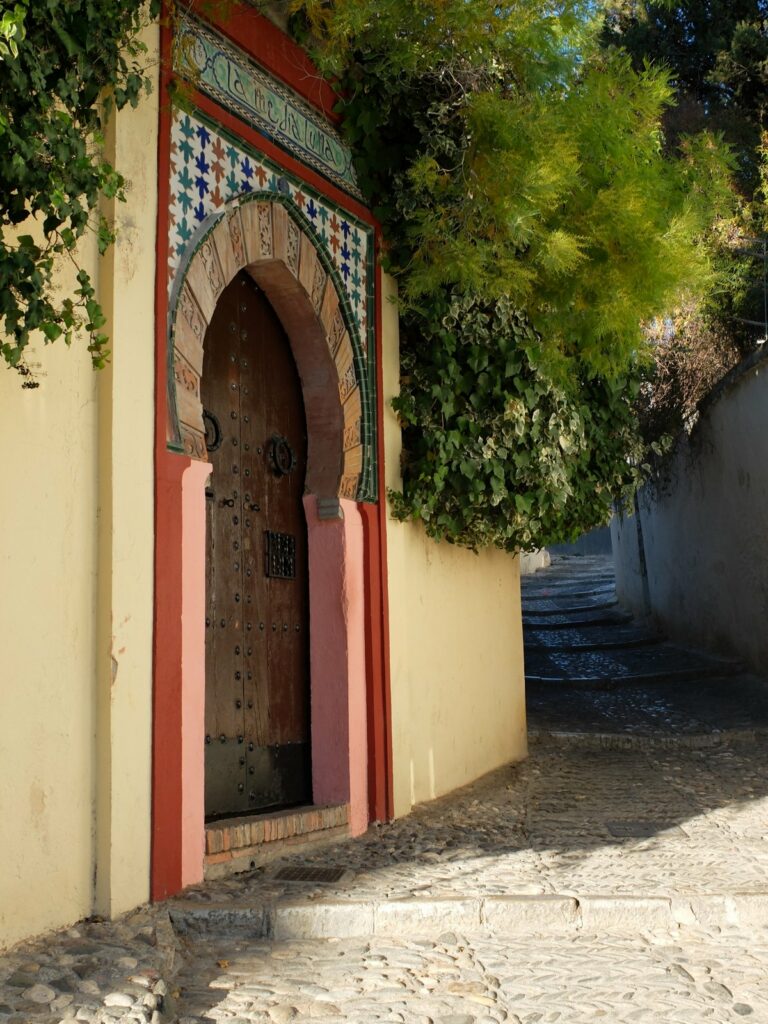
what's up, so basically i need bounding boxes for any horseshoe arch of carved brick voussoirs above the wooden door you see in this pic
[167,196,375,501]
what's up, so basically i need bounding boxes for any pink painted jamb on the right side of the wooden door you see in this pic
[304,495,369,836]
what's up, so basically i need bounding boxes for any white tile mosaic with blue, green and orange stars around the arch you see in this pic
[168,111,374,351]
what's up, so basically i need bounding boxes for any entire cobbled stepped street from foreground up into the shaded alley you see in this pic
[0,557,768,1024]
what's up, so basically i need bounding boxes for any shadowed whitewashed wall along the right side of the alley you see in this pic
[612,352,768,672]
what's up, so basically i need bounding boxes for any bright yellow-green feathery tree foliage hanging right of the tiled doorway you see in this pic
[292,0,730,373]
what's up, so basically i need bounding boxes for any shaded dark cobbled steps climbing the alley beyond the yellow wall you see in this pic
[522,556,768,733]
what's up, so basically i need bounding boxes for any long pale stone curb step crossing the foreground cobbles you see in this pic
[169,891,768,942]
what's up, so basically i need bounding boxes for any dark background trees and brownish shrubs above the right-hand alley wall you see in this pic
[603,0,768,448]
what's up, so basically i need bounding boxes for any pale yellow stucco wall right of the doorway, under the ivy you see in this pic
[382,278,527,815]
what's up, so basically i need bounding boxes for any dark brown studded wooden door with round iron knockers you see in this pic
[202,272,311,818]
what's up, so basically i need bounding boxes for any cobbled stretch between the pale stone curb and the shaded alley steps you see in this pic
[171,739,768,904]
